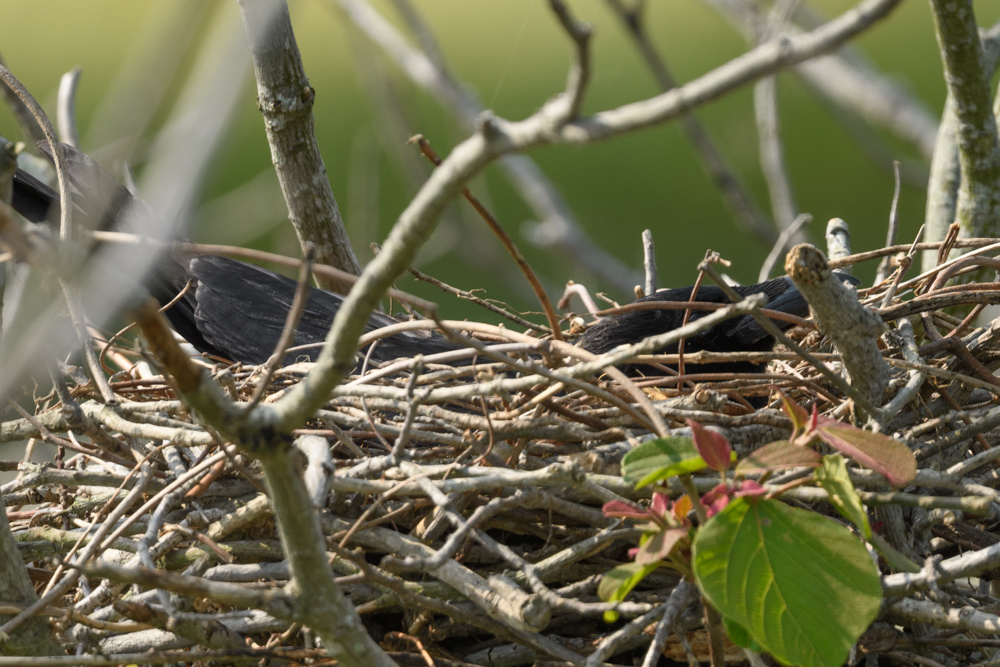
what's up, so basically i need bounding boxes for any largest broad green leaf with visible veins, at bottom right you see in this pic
[692,498,882,667]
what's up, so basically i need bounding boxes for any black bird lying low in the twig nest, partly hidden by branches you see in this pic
[12,146,854,374]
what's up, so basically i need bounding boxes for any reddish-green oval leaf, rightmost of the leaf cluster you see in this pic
[816,417,917,488]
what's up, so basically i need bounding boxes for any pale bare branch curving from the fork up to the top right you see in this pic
[274,0,900,429]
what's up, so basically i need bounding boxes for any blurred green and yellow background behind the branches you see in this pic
[0,0,1000,321]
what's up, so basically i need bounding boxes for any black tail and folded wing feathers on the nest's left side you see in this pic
[12,147,456,364]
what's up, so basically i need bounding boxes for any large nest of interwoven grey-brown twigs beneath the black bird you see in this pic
[0,241,1000,665]
